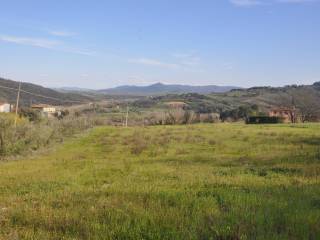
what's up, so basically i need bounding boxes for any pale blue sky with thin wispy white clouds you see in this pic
[0,0,320,89]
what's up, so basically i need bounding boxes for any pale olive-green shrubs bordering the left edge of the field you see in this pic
[0,114,105,159]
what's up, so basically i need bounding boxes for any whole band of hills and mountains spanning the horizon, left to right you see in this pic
[0,78,320,119]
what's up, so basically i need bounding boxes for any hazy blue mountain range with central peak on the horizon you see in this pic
[98,83,239,96]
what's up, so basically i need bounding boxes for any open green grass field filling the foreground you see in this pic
[0,124,320,240]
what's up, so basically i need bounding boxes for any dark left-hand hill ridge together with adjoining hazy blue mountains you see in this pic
[0,78,237,106]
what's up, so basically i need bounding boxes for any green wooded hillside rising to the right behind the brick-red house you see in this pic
[134,82,320,120]
